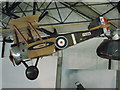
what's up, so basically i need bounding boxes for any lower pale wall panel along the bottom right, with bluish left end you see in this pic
[61,70,116,88]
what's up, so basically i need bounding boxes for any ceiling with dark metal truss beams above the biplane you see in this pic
[0,0,120,32]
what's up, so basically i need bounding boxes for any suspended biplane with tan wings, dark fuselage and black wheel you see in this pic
[0,15,110,80]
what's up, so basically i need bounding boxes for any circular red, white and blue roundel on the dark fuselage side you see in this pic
[55,36,68,49]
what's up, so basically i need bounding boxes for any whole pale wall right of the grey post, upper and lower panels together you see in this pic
[61,38,118,88]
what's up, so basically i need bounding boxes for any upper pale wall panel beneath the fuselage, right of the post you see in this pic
[63,38,118,69]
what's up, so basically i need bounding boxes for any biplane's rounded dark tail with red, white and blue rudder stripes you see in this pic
[88,17,109,34]
